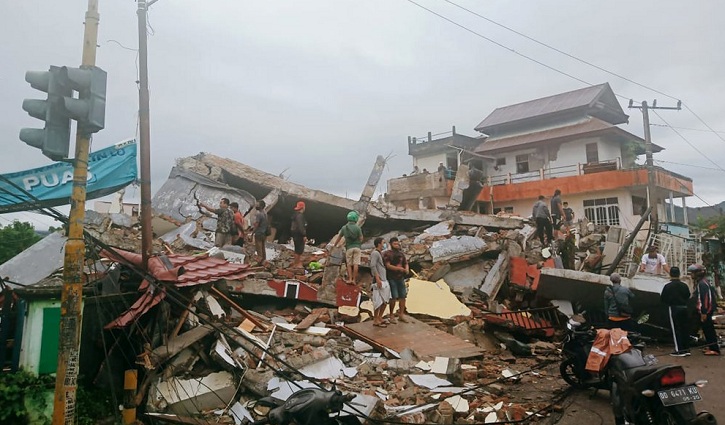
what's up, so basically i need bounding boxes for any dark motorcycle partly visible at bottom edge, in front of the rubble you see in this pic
[252,388,360,425]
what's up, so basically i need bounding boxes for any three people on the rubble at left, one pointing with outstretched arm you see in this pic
[198,198,270,264]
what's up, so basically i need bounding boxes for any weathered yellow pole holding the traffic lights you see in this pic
[53,0,99,425]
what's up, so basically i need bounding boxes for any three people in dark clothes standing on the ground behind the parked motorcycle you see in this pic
[604,264,720,357]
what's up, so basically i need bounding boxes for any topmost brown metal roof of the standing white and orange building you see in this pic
[476,83,626,134]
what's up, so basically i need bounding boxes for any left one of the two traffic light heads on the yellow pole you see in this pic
[20,66,73,161]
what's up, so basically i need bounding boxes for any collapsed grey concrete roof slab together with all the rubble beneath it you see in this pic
[14,154,688,424]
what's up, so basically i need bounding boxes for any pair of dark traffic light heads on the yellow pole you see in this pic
[20,66,106,161]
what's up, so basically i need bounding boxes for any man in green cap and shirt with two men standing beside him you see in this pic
[338,211,410,328]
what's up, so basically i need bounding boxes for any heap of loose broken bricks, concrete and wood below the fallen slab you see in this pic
[72,206,624,424]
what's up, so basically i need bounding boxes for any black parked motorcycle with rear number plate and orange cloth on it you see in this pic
[559,318,717,425]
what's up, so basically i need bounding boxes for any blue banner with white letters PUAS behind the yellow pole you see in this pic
[0,139,138,214]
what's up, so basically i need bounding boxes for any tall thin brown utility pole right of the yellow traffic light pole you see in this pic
[136,0,158,269]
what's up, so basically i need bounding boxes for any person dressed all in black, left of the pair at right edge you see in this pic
[660,266,690,357]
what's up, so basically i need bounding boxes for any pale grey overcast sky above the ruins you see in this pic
[0,0,725,226]
